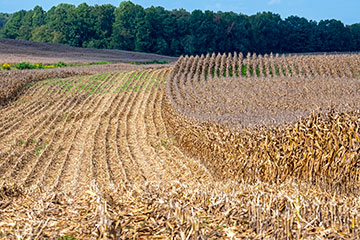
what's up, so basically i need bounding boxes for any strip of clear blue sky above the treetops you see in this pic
[0,0,360,24]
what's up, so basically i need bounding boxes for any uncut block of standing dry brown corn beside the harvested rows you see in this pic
[163,54,360,192]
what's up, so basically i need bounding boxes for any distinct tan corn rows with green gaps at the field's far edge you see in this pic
[172,52,360,79]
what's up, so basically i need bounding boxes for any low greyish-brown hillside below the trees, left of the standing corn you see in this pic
[0,38,177,63]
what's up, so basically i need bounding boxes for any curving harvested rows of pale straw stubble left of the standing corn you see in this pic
[0,69,212,193]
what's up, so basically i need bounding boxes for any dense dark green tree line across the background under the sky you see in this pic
[0,1,360,56]
